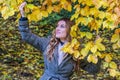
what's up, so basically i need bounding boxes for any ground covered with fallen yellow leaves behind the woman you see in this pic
[0,18,120,80]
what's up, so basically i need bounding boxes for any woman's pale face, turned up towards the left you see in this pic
[55,20,68,41]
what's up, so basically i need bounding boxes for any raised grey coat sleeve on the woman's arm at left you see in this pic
[19,17,50,52]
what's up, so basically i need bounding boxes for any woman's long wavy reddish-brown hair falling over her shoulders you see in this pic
[47,18,74,61]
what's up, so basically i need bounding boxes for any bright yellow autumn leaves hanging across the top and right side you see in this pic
[0,0,120,77]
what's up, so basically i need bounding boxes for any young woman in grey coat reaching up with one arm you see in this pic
[19,2,75,80]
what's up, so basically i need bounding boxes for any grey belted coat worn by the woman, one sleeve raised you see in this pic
[19,19,75,80]
